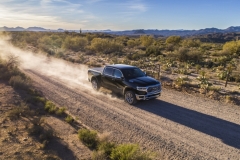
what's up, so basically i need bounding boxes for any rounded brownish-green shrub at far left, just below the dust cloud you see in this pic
[9,76,30,89]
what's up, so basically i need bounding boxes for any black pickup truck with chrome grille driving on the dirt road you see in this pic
[88,64,161,104]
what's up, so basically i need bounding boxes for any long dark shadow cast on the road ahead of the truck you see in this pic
[135,99,240,149]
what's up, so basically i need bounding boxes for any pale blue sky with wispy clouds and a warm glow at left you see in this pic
[0,0,240,30]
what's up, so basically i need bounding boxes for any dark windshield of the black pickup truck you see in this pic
[122,68,146,79]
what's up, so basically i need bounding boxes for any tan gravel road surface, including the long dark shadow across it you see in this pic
[26,70,240,160]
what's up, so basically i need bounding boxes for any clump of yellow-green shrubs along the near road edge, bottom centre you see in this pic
[78,129,156,160]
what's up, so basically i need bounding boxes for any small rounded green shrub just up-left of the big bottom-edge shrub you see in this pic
[78,129,99,149]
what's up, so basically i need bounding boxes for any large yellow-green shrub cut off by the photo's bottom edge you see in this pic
[110,144,154,160]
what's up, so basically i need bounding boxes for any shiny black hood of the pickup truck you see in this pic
[129,76,159,87]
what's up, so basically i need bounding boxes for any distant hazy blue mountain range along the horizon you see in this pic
[0,26,240,37]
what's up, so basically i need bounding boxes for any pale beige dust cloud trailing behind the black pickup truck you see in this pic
[0,36,91,89]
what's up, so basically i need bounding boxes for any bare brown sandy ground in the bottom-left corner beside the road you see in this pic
[0,81,92,160]
